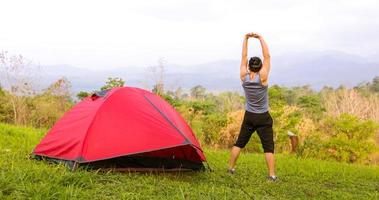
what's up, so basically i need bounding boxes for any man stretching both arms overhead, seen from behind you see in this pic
[228,33,277,181]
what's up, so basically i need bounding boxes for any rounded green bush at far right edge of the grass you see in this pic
[301,114,379,163]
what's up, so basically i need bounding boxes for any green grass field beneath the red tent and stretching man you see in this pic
[0,124,379,199]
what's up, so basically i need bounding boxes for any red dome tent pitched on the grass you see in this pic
[33,87,205,170]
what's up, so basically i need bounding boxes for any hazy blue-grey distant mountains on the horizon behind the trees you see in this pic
[24,52,379,92]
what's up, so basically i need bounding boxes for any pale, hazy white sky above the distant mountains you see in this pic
[0,0,379,69]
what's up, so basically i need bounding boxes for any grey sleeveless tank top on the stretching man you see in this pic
[242,73,268,113]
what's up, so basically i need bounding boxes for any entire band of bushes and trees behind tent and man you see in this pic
[0,70,379,163]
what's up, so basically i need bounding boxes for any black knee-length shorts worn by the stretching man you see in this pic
[234,111,274,153]
